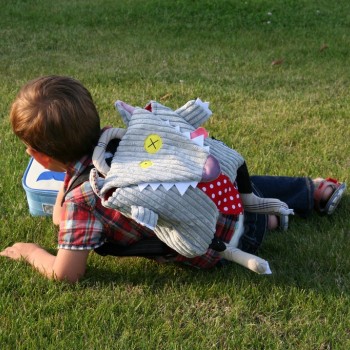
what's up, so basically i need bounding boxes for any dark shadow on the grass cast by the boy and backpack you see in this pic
[77,200,350,295]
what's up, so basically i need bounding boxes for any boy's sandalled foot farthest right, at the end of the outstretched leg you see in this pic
[313,178,346,215]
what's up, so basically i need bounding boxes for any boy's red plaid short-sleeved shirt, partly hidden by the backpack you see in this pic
[58,157,236,268]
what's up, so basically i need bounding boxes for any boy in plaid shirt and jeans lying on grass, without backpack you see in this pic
[0,76,346,282]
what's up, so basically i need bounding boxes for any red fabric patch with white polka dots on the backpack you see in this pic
[197,174,243,215]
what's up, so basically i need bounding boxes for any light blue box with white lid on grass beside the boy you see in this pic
[22,158,65,216]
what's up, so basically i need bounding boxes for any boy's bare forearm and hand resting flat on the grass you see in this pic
[0,243,89,283]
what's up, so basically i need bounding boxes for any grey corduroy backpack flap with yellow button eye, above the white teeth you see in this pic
[101,109,209,190]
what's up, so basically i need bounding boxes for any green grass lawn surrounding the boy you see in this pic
[0,0,350,350]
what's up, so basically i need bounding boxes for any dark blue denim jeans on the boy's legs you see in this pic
[239,176,314,254]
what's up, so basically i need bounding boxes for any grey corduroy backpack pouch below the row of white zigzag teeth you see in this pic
[102,186,219,257]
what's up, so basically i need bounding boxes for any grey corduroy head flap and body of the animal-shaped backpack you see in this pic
[91,101,244,258]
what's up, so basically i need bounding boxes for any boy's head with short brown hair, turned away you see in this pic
[10,76,100,163]
